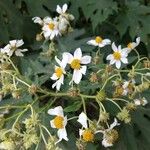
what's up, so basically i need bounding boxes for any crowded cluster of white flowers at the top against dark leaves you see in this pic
[32,4,74,40]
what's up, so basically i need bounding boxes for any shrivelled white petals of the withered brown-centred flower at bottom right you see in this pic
[96,118,120,147]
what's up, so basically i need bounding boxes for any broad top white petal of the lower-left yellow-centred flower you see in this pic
[48,106,64,117]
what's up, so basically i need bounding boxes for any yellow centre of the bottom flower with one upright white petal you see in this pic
[82,129,94,142]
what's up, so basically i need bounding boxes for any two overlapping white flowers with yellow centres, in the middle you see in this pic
[51,48,91,91]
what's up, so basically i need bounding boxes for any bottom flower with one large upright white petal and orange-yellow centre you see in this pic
[77,112,94,142]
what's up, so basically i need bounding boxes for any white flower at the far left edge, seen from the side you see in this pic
[1,40,28,57]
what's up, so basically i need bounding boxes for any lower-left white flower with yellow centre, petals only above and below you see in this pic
[48,106,68,144]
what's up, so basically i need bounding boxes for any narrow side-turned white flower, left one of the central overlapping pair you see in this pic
[51,54,68,91]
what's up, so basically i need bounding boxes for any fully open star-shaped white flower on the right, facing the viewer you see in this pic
[106,42,128,69]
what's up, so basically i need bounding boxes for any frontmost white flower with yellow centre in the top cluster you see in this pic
[42,17,61,40]
